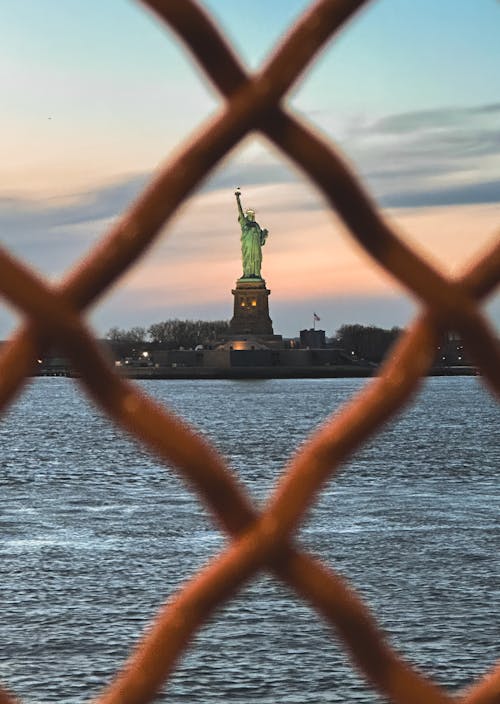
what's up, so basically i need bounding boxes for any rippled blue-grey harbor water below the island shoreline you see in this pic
[0,377,500,704]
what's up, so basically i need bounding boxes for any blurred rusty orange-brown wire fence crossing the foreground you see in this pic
[0,0,500,704]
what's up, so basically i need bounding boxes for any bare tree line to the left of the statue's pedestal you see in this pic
[105,318,229,350]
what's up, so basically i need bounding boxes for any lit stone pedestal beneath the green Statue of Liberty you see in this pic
[230,279,274,336]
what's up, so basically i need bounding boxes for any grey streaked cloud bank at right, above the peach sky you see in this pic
[316,103,500,207]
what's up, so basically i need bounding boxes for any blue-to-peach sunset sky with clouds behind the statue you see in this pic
[0,0,500,339]
